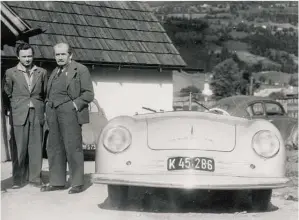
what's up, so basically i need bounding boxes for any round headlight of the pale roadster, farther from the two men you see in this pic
[252,131,280,158]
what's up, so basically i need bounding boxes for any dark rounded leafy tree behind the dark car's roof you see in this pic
[211,59,243,99]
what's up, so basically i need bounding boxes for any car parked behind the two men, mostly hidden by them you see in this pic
[43,99,108,160]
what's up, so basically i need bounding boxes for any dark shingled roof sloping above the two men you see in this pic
[2,1,186,67]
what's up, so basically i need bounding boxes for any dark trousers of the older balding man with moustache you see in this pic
[46,101,84,186]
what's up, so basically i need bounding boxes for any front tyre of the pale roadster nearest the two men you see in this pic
[108,185,129,208]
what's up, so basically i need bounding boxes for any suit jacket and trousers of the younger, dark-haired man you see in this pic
[4,67,48,184]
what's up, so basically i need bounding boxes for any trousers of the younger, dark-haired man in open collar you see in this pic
[12,108,43,184]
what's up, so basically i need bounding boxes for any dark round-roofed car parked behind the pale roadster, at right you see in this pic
[210,95,298,148]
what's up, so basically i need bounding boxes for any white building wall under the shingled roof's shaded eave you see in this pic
[91,68,173,120]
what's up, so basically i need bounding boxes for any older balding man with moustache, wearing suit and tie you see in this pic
[41,43,94,194]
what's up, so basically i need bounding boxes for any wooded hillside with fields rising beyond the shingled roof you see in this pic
[148,1,298,78]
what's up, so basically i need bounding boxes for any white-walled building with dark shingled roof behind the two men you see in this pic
[1,1,186,119]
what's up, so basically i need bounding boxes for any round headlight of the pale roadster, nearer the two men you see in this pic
[103,126,132,153]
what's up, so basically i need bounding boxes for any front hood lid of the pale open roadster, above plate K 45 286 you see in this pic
[134,112,248,152]
